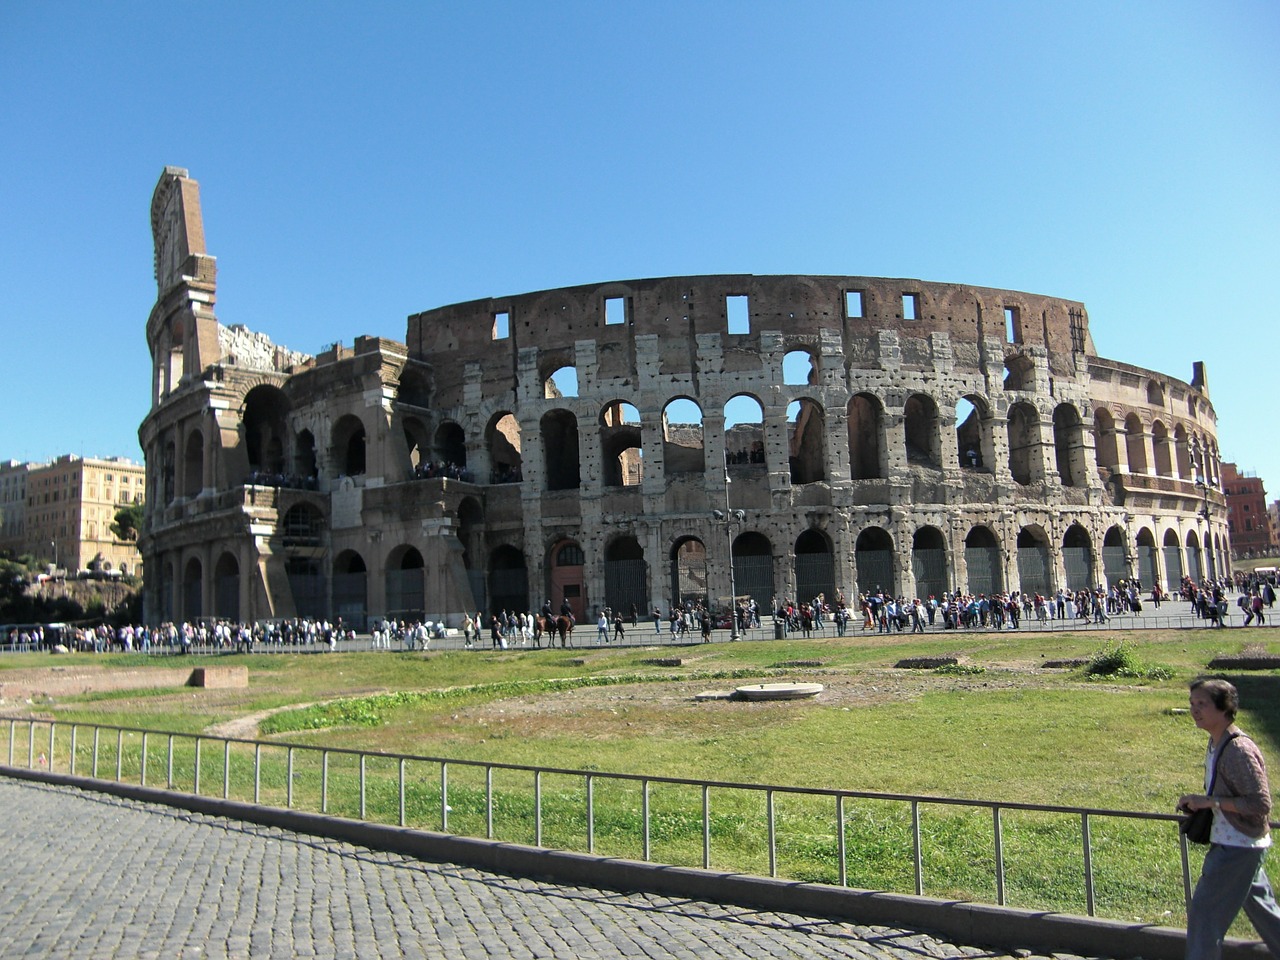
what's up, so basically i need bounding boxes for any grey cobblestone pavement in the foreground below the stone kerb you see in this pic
[0,778,1100,960]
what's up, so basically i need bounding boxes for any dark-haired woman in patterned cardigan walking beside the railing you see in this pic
[1178,680,1280,960]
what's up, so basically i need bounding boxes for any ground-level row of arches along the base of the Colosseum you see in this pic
[154,506,1225,628]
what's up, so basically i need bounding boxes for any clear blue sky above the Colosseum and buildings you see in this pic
[0,0,1280,497]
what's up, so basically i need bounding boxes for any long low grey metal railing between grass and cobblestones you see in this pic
[0,717,1239,923]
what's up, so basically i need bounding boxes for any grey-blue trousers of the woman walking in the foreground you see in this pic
[1187,844,1280,960]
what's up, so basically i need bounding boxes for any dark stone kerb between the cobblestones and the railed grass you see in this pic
[0,764,1268,960]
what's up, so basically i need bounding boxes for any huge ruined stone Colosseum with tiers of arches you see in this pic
[140,168,1230,626]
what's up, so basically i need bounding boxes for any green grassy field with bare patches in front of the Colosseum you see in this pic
[0,630,1280,932]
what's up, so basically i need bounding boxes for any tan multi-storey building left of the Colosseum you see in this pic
[0,453,146,576]
